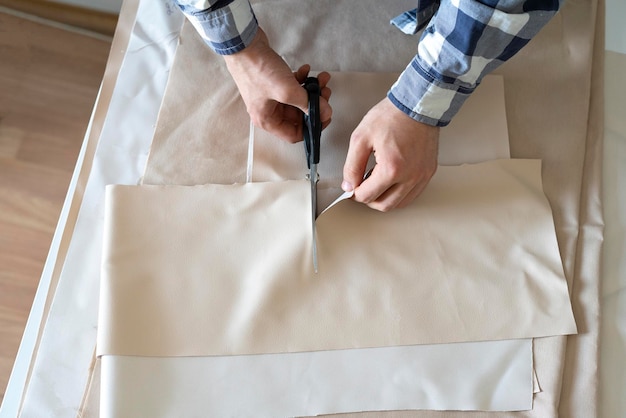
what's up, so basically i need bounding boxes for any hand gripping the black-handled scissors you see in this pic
[224,28,332,142]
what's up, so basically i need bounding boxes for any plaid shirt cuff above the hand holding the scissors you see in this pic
[176,0,258,55]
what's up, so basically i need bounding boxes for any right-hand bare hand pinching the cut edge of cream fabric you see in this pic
[342,98,439,212]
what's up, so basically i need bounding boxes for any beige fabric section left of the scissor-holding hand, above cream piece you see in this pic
[143,28,250,185]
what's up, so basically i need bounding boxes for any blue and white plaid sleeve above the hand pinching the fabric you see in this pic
[387,0,562,126]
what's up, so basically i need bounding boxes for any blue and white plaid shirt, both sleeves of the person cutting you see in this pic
[176,0,564,126]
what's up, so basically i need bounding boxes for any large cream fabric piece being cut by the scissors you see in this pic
[98,160,576,356]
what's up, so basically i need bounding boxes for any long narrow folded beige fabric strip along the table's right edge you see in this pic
[559,0,605,416]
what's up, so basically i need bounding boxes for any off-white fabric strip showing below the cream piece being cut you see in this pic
[100,340,532,418]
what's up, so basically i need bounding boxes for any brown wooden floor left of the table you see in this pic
[0,12,110,401]
